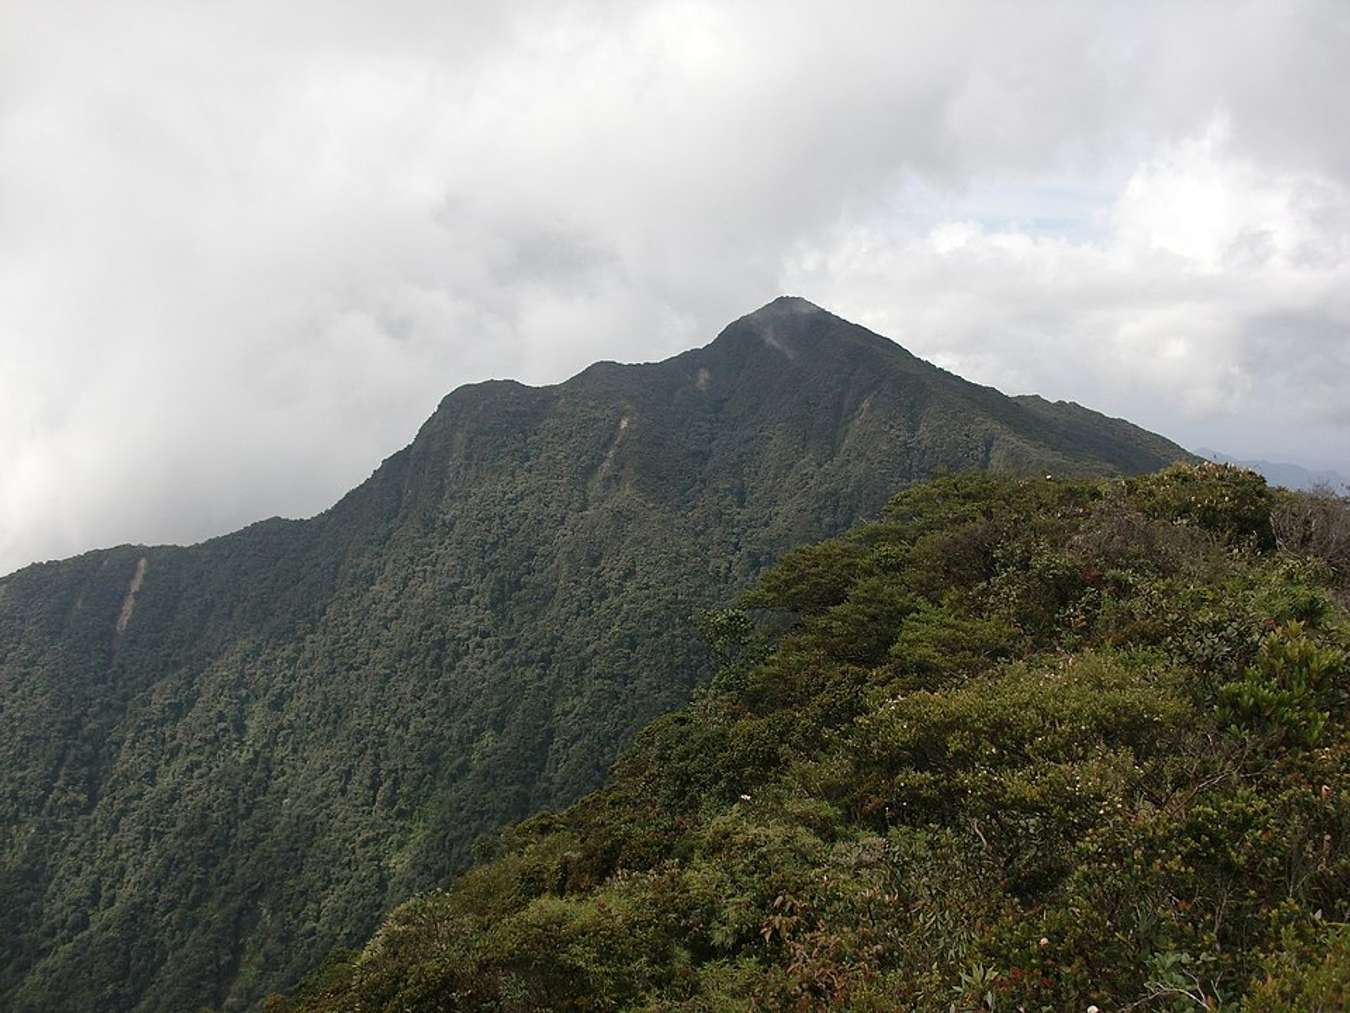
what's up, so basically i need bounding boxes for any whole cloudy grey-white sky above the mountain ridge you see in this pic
[0,0,1350,573]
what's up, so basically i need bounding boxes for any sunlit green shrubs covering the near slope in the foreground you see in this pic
[269,466,1350,1013]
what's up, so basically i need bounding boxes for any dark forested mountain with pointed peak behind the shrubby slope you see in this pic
[0,298,1187,1010]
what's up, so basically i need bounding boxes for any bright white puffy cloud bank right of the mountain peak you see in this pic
[788,116,1350,458]
